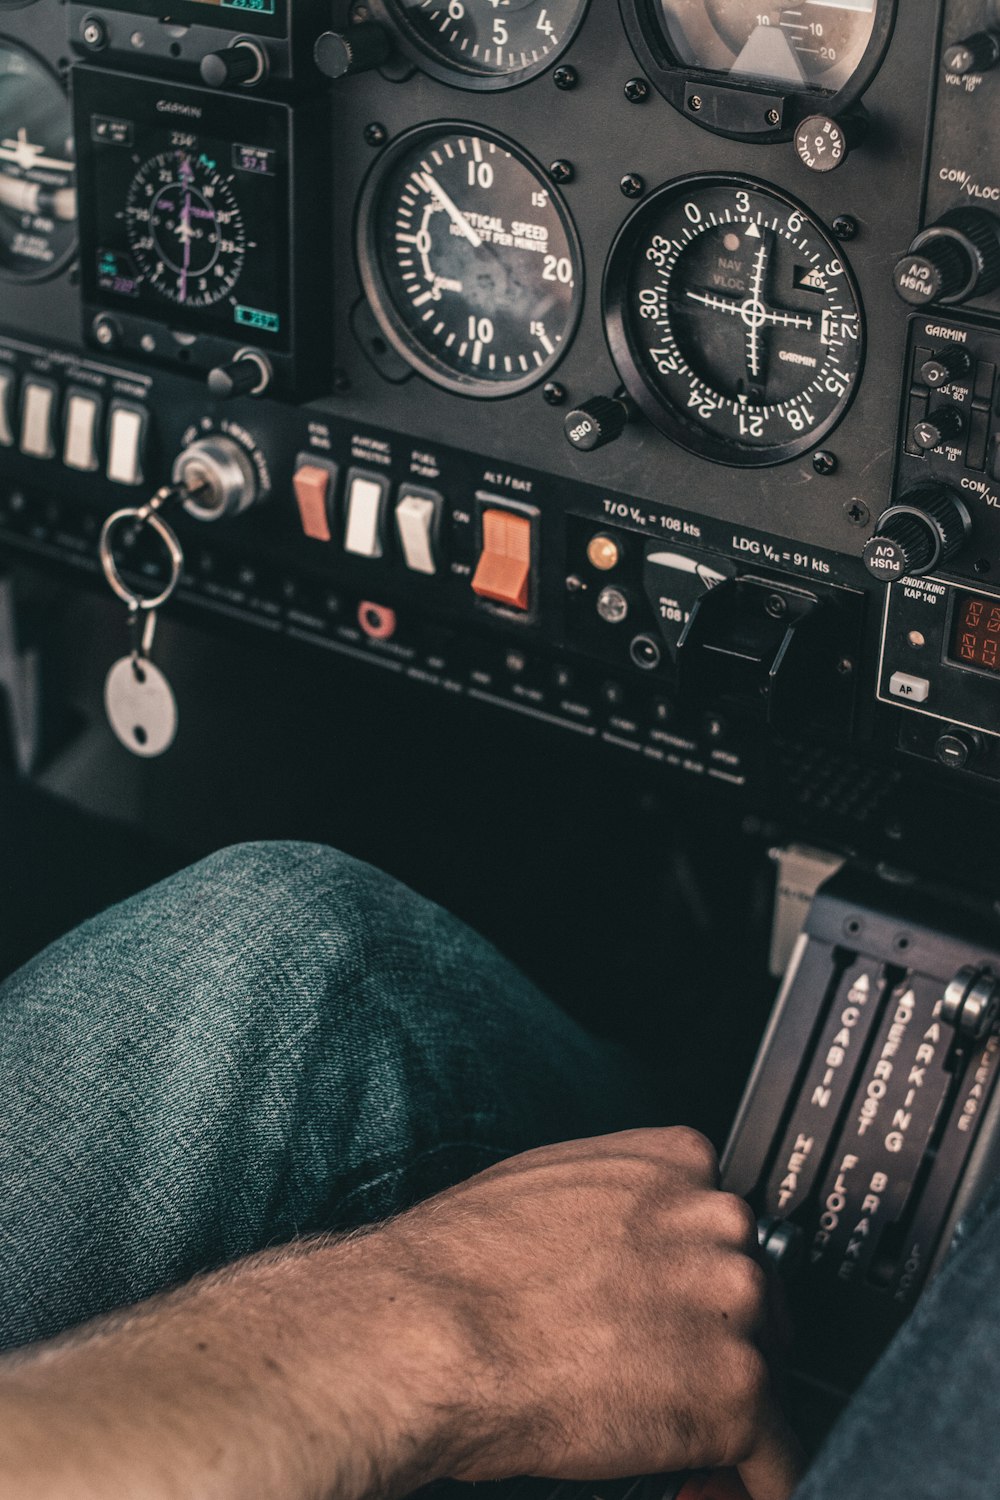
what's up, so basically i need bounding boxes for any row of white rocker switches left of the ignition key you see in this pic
[0,366,148,486]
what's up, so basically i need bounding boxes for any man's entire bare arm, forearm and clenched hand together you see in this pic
[0,1130,798,1500]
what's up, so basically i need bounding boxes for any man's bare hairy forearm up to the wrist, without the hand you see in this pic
[0,1236,464,1500]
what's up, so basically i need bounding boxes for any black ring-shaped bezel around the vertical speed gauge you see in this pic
[354,120,586,401]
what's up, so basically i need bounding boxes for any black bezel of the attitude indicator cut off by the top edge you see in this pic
[619,0,898,146]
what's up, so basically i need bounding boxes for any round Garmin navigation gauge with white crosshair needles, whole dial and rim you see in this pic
[604,177,864,467]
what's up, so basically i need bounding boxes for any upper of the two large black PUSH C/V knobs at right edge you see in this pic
[894,209,1000,308]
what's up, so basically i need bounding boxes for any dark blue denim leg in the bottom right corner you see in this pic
[795,1184,1000,1500]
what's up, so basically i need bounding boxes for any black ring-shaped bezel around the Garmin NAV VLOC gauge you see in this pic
[603,173,868,470]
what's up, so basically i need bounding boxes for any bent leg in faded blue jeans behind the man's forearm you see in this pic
[0,845,651,1347]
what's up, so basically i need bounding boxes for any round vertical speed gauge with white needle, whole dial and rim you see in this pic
[358,125,583,398]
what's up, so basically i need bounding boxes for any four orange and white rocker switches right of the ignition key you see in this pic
[294,455,537,614]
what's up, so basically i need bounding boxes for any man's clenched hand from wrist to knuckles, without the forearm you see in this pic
[379,1130,801,1500]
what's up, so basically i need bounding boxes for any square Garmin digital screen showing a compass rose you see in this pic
[73,69,291,353]
